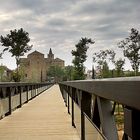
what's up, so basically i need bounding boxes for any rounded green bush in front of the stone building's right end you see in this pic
[47,66,64,82]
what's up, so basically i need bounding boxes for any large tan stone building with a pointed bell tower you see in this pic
[20,49,65,82]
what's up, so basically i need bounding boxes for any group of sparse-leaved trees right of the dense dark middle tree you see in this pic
[93,28,140,78]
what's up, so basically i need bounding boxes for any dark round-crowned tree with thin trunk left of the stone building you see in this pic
[0,28,32,81]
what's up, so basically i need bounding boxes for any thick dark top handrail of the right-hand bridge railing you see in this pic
[60,77,140,110]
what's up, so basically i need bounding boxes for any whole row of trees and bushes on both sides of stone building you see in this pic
[0,28,140,82]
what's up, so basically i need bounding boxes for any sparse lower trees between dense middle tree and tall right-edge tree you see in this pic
[93,50,125,78]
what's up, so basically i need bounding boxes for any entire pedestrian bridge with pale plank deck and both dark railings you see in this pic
[0,77,140,140]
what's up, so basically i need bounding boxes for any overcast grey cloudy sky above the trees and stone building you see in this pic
[0,0,140,69]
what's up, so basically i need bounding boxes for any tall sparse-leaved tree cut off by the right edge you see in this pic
[118,28,140,75]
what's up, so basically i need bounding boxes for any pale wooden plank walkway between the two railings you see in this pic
[0,85,80,140]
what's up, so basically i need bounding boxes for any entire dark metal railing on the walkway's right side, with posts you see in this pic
[59,77,140,140]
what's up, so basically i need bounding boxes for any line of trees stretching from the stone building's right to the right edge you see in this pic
[47,28,140,80]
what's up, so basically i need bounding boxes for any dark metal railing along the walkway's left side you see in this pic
[0,83,52,119]
